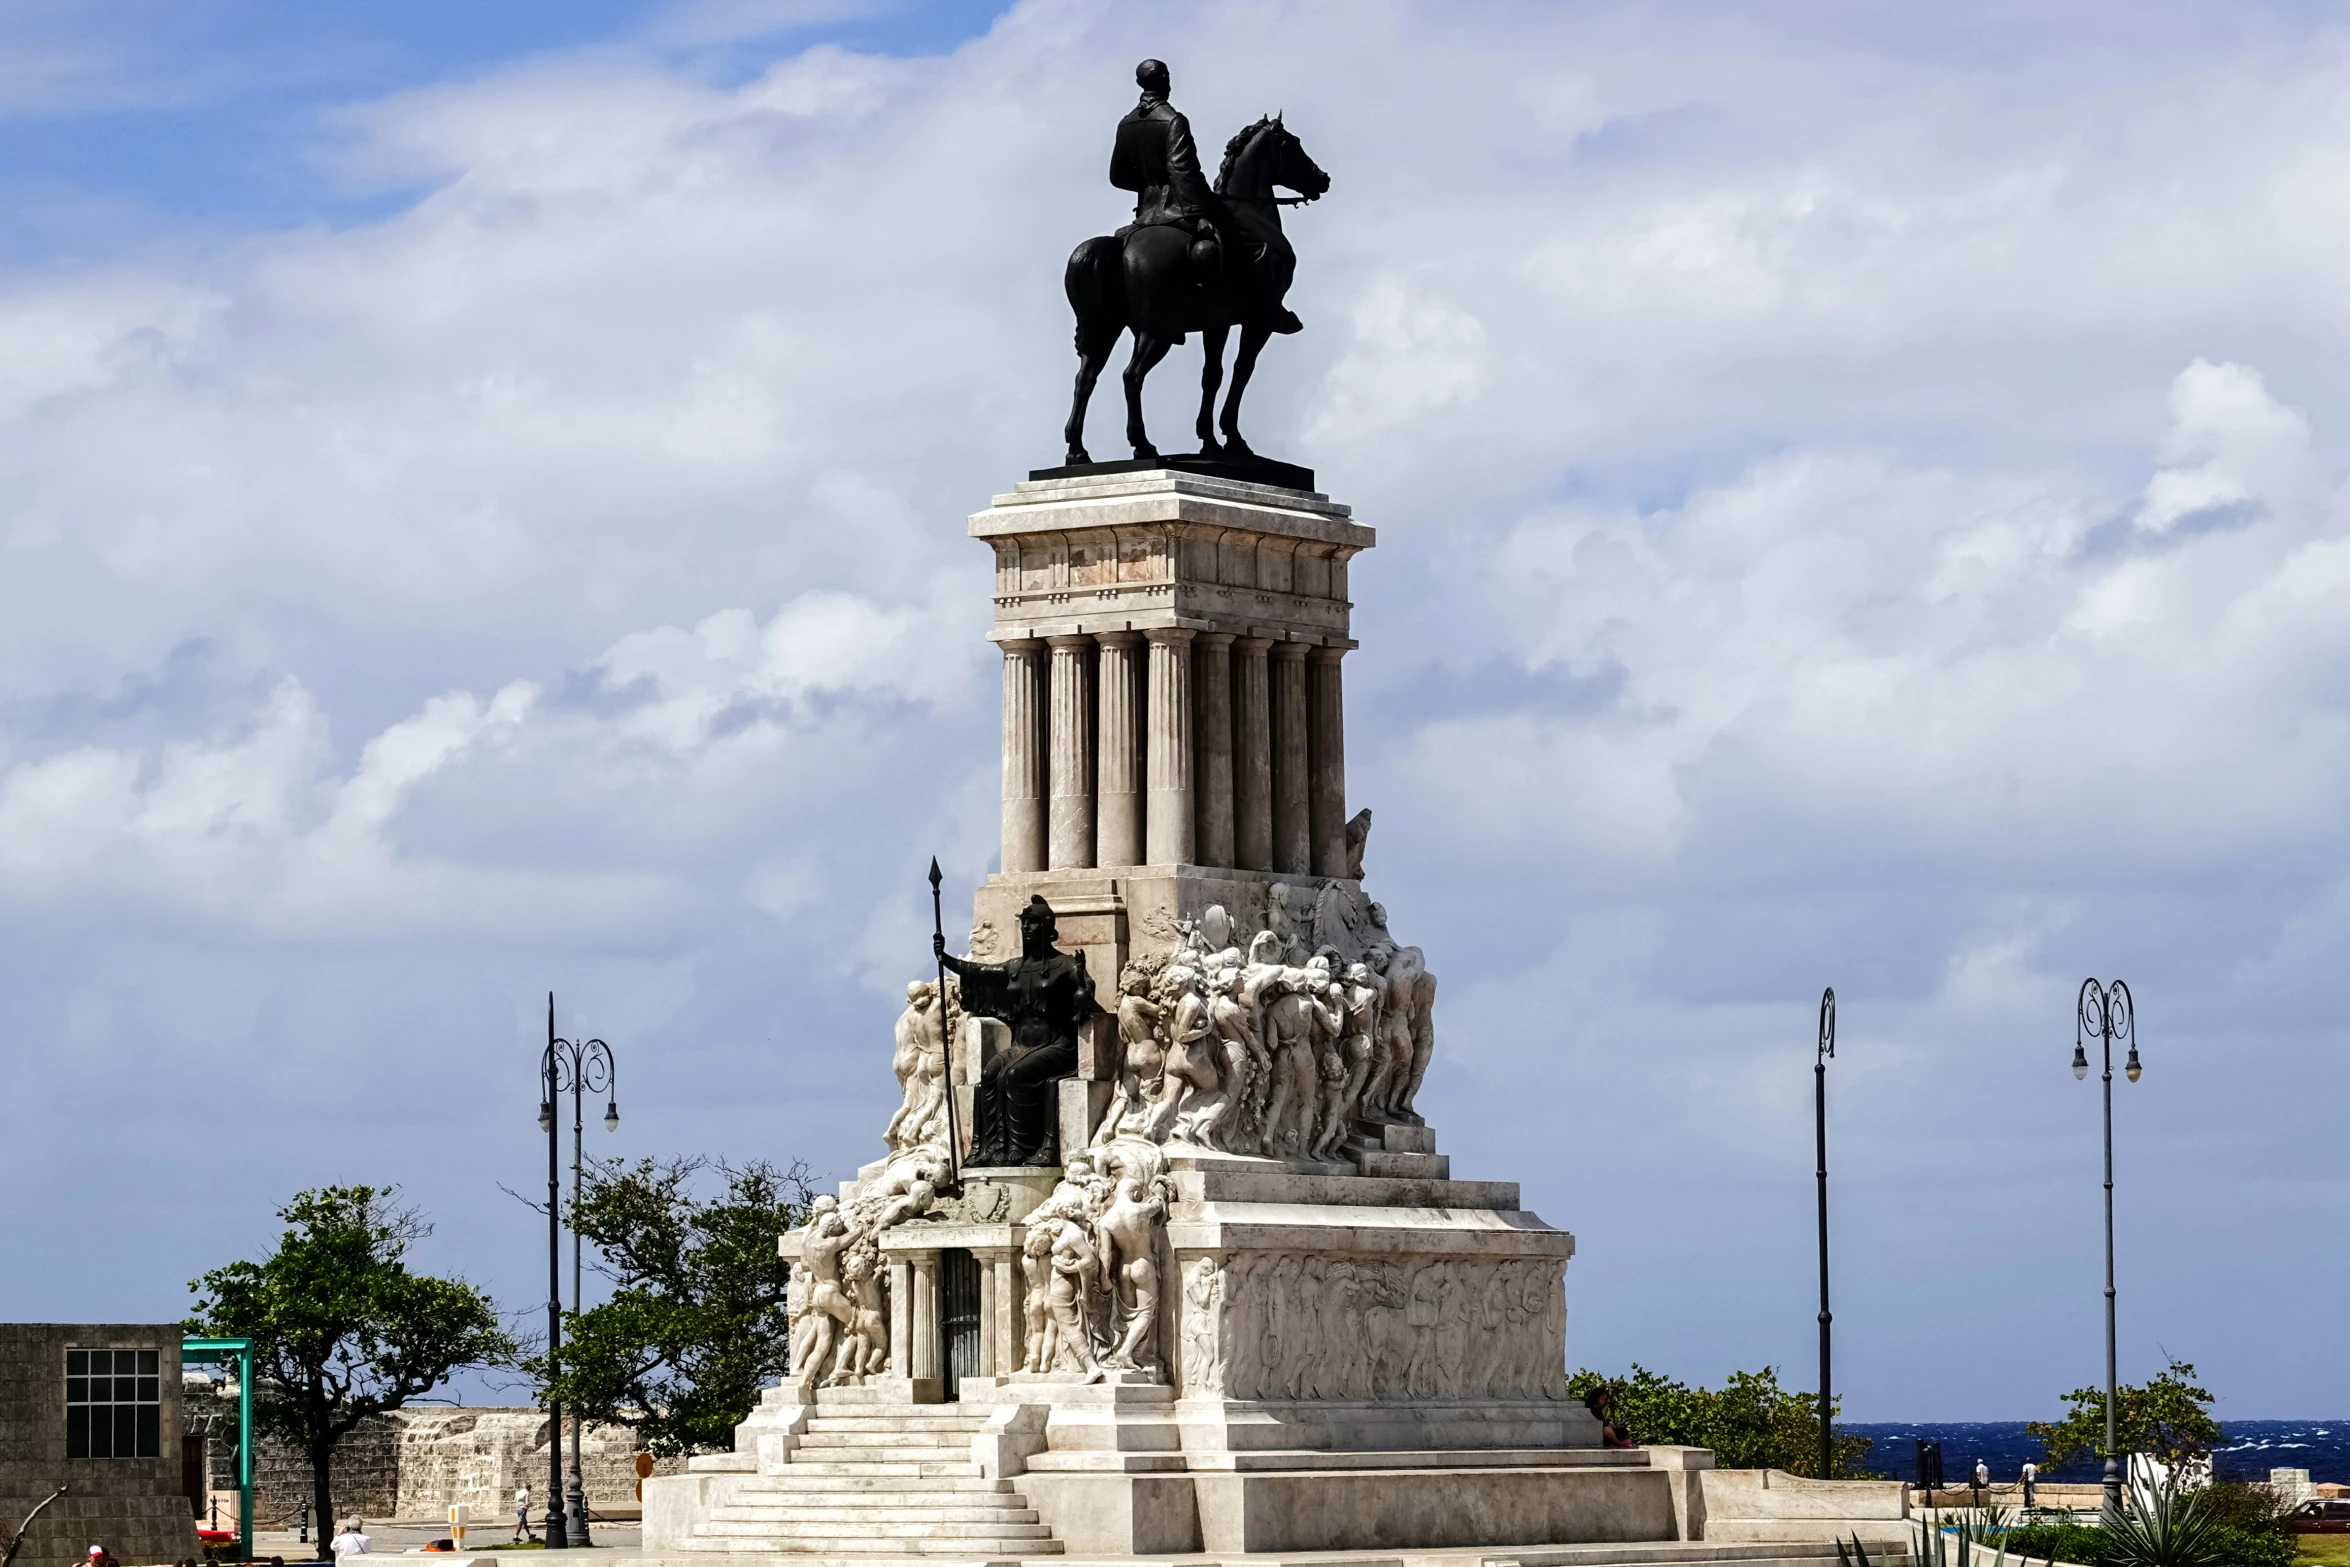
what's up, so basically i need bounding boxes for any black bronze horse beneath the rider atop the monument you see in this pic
[1065,115,1330,465]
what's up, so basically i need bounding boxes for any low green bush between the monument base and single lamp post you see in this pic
[1567,1363,1868,1480]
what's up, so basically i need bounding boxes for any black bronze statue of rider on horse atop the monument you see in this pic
[1065,59,1330,465]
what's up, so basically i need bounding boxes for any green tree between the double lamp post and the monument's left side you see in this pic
[522,1158,811,1454]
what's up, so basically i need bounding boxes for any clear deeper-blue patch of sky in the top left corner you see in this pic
[0,0,1001,254]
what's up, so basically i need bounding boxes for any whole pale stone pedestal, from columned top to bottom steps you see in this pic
[646,472,1704,1560]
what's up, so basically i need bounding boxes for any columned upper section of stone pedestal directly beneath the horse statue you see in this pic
[971,472,1377,994]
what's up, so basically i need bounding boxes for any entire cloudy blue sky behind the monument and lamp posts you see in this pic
[0,0,2350,1419]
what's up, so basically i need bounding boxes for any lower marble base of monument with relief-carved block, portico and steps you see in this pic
[644,1123,1654,1558]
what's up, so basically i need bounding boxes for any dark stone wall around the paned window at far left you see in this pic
[0,1323,197,1567]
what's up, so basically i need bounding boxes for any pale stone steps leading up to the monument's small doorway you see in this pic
[693,1398,1060,1560]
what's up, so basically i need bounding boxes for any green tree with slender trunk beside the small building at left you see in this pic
[188,1186,515,1560]
